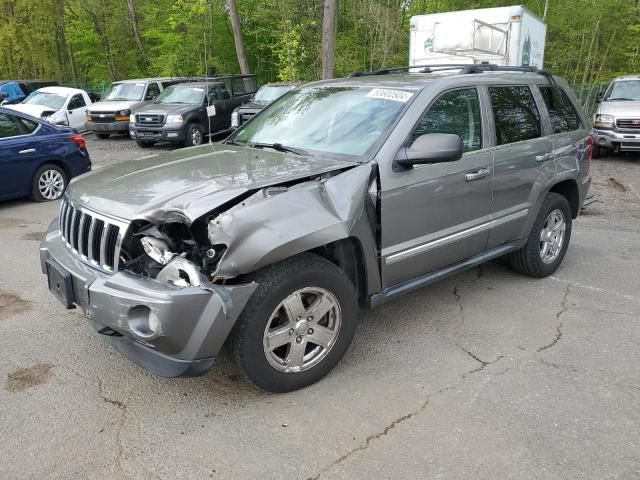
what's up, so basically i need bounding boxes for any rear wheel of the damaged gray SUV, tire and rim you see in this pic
[508,193,572,278]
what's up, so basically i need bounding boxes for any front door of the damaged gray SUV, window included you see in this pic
[381,87,493,288]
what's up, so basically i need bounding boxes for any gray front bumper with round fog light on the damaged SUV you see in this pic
[40,220,257,377]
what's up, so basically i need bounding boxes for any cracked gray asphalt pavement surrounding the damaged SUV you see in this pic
[0,137,640,480]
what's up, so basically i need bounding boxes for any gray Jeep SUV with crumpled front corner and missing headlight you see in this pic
[40,65,592,392]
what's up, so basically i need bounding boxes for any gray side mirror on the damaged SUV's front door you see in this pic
[395,133,464,168]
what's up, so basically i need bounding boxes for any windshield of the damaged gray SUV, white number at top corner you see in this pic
[231,86,413,156]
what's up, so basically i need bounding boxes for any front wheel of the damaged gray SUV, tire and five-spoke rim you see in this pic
[228,253,358,392]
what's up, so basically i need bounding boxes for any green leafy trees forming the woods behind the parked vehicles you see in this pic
[0,0,640,91]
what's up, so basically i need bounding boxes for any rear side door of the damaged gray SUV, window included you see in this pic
[487,84,556,248]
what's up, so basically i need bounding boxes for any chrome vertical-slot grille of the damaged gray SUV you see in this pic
[60,198,127,272]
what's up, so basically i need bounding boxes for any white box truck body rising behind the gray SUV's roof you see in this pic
[409,5,547,68]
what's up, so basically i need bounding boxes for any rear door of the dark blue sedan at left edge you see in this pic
[0,113,44,198]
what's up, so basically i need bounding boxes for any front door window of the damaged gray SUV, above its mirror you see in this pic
[411,88,482,152]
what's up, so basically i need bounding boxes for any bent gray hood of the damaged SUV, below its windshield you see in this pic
[67,144,355,223]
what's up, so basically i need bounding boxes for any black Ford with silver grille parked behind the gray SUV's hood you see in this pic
[129,75,257,147]
